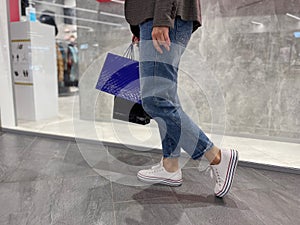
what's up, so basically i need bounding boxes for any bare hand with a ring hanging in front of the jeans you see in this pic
[152,27,171,54]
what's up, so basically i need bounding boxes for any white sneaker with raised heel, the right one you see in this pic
[211,149,238,198]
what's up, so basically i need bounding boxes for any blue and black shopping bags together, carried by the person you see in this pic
[96,44,151,125]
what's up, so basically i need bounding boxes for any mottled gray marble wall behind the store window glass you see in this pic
[77,0,300,138]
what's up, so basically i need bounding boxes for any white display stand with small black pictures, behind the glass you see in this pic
[11,22,58,120]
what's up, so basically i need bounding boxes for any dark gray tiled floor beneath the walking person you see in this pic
[0,133,300,225]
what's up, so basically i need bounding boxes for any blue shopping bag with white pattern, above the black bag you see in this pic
[96,46,141,104]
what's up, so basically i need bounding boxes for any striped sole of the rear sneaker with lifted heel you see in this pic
[216,150,239,198]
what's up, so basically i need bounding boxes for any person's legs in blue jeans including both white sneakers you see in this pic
[138,19,238,197]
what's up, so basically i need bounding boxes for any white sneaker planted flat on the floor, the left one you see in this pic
[137,161,182,186]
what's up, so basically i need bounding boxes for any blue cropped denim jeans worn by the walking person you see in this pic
[139,18,213,159]
